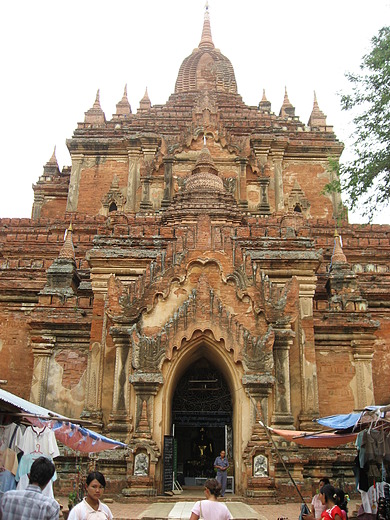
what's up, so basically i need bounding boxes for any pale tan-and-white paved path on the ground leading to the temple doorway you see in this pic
[138,501,264,520]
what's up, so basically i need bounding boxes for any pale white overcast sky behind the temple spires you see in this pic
[0,0,390,223]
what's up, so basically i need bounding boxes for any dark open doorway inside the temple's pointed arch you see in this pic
[172,357,233,486]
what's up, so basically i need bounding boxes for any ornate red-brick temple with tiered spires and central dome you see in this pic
[0,10,390,500]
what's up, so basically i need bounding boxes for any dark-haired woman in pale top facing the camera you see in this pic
[68,471,113,520]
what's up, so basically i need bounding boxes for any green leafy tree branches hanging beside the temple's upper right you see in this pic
[339,27,390,219]
